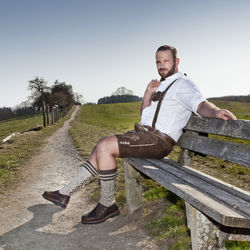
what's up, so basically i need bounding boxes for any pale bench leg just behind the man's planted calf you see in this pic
[124,160,142,213]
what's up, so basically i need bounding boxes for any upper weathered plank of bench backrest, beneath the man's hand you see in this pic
[184,116,250,140]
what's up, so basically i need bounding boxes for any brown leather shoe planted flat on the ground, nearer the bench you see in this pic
[81,203,120,224]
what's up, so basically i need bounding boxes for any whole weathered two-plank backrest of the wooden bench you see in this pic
[177,116,250,167]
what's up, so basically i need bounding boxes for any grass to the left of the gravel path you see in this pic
[0,109,73,193]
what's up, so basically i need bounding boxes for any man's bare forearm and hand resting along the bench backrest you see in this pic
[197,101,237,120]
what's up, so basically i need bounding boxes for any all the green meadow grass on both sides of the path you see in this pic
[0,101,250,249]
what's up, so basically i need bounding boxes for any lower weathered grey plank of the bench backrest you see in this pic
[177,133,250,167]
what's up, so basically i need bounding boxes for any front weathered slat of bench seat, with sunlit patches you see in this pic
[126,158,250,228]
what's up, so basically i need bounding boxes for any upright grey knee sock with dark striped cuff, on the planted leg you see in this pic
[99,169,117,207]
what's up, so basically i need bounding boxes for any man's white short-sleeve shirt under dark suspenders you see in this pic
[141,72,206,141]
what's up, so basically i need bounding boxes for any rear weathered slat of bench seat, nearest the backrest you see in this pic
[148,159,250,218]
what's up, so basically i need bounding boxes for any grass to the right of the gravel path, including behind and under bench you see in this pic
[70,101,250,249]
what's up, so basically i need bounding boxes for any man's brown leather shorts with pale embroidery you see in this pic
[115,123,175,159]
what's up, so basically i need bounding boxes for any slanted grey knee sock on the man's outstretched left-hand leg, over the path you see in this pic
[59,161,97,196]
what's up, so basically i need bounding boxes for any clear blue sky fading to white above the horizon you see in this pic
[0,0,250,107]
